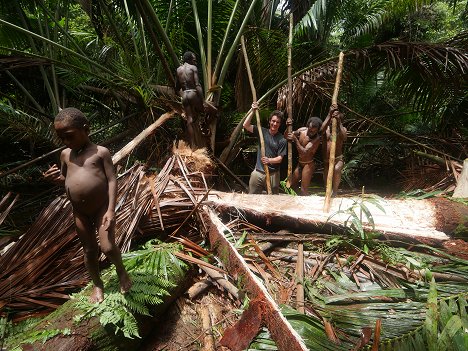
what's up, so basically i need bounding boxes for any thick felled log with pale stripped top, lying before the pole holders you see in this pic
[208,192,468,245]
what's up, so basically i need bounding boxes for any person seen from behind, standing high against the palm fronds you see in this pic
[176,51,204,146]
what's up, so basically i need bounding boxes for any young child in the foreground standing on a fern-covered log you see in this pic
[44,107,132,303]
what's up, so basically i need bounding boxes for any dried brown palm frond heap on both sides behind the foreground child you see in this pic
[0,145,213,320]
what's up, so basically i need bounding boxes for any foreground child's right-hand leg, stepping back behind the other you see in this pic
[97,217,132,294]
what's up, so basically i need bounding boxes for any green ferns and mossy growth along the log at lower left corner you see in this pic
[0,240,188,351]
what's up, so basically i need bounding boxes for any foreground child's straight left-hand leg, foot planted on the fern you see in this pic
[74,212,104,303]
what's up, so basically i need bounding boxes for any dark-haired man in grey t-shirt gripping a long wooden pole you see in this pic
[243,102,287,194]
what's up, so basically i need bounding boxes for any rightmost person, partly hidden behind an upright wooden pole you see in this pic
[320,104,348,196]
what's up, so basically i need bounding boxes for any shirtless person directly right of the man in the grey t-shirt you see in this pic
[286,117,322,196]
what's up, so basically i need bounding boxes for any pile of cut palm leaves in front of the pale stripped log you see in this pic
[227,218,468,351]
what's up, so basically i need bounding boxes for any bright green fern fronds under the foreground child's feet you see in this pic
[74,240,187,338]
